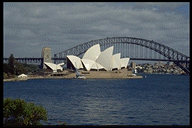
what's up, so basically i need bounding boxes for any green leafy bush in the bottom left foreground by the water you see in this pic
[3,98,47,125]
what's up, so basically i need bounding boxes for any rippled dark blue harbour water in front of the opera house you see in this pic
[3,74,190,125]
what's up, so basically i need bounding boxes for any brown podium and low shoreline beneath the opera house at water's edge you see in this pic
[3,69,143,81]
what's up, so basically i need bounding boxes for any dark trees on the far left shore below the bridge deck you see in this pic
[3,54,41,78]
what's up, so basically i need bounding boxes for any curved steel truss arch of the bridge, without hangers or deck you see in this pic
[54,37,190,74]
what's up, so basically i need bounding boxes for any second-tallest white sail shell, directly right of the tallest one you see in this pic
[96,46,114,71]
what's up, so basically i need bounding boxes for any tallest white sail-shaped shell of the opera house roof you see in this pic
[82,44,101,61]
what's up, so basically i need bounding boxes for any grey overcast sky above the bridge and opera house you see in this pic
[3,2,190,57]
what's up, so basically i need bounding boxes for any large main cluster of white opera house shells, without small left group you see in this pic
[67,44,129,71]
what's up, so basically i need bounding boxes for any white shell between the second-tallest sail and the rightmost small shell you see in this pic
[111,53,121,70]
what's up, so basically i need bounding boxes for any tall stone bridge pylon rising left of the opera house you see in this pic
[41,47,52,69]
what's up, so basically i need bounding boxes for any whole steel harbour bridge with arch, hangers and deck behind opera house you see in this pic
[3,37,190,74]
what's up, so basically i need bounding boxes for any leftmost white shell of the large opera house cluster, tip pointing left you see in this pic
[67,55,83,69]
